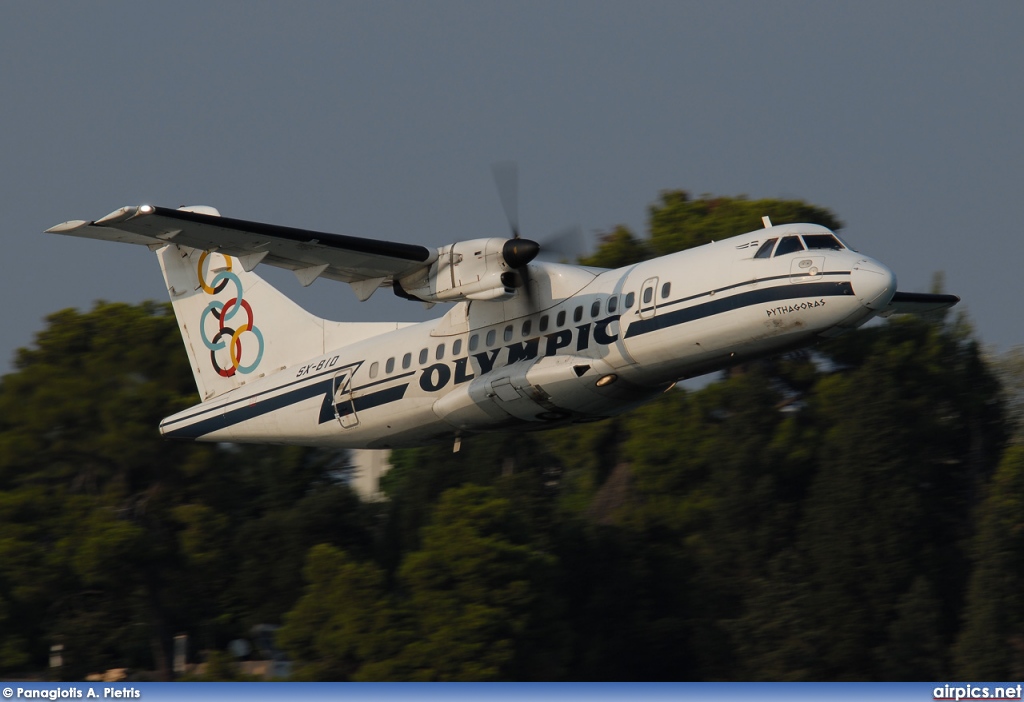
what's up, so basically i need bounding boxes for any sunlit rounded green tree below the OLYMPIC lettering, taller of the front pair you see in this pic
[378,485,555,681]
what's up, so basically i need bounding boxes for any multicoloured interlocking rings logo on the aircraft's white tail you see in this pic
[197,251,264,378]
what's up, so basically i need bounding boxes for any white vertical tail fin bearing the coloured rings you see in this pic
[157,245,396,401]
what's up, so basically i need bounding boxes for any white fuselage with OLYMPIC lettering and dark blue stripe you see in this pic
[161,224,896,448]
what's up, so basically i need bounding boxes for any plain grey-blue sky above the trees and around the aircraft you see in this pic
[0,0,1024,372]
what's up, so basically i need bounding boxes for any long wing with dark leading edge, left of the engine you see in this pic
[46,205,437,300]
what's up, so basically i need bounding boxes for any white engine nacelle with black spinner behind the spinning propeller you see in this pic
[395,238,540,302]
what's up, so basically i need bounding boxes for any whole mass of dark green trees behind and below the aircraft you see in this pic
[0,191,1024,681]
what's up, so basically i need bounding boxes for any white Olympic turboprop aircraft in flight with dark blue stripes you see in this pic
[47,198,959,450]
